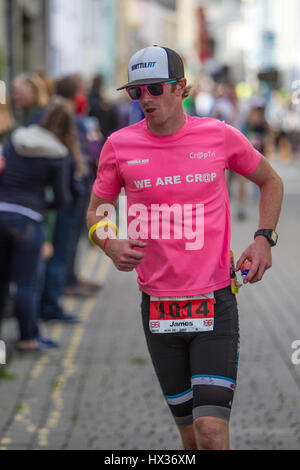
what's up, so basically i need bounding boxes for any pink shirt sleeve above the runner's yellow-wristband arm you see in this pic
[93,139,123,199]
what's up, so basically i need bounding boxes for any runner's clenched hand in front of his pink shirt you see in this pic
[105,239,147,272]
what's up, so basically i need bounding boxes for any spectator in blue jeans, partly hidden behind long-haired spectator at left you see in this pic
[40,75,96,302]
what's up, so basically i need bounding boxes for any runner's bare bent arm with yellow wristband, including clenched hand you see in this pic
[87,192,147,272]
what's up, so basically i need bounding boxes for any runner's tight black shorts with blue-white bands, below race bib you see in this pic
[142,286,239,426]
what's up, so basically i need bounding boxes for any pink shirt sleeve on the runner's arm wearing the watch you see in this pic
[225,124,262,176]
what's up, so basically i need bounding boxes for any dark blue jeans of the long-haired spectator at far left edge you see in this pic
[0,212,43,341]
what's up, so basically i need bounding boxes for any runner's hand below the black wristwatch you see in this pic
[235,236,272,284]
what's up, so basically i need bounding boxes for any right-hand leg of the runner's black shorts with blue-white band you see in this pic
[190,287,239,420]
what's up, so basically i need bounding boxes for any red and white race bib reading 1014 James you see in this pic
[149,292,215,333]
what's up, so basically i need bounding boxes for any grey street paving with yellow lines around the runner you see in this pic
[0,156,300,450]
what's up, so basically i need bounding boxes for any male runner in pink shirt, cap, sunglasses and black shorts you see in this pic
[87,46,283,449]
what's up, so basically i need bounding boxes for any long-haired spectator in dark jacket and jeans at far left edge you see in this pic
[0,98,83,352]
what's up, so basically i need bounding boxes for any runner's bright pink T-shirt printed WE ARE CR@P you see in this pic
[93,115,262,297]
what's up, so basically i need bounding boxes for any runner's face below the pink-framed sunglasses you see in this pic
[139,80,185,130]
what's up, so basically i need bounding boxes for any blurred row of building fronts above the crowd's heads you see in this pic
[0,0,300,95]
